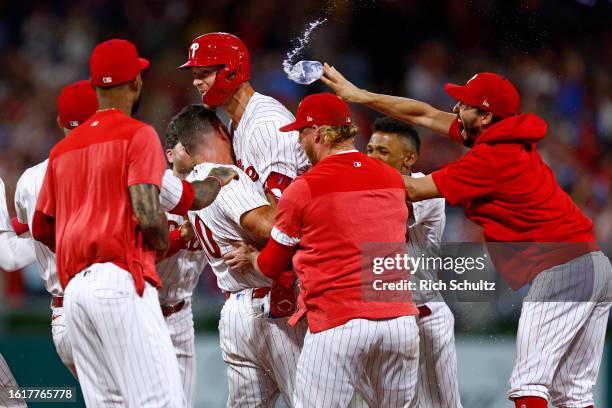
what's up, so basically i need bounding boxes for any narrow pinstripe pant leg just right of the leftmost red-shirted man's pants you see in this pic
[165,298,197,407]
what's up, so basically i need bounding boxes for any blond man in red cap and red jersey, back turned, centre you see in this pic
[227,94,419,408]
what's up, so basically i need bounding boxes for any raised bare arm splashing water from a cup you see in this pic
[321,63,457,135]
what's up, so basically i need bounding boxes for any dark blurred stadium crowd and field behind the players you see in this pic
[0,0,612,407]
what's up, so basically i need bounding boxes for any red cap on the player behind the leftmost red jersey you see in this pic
[57,81,98,129]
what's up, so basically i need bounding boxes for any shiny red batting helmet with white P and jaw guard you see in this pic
[177,33,251,106]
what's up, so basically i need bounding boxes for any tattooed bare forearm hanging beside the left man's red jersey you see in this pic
[129,184,168,251]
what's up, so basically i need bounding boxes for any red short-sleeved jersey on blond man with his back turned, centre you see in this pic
[272,152,417,333]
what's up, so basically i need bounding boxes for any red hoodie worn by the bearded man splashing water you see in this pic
[432,113,597,289]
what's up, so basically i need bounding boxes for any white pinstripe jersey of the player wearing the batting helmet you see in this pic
[230,92,310,186]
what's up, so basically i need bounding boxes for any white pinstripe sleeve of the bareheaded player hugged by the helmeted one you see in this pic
[217,172,270,225]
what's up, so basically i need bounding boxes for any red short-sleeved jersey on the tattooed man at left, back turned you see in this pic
[36,109,166,293]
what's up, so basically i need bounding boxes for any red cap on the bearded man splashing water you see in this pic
[444,72,521,118]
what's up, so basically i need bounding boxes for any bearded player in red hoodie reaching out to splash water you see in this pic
[323,64,612,408]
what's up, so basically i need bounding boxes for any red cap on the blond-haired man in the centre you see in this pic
[279,93,353,132]
